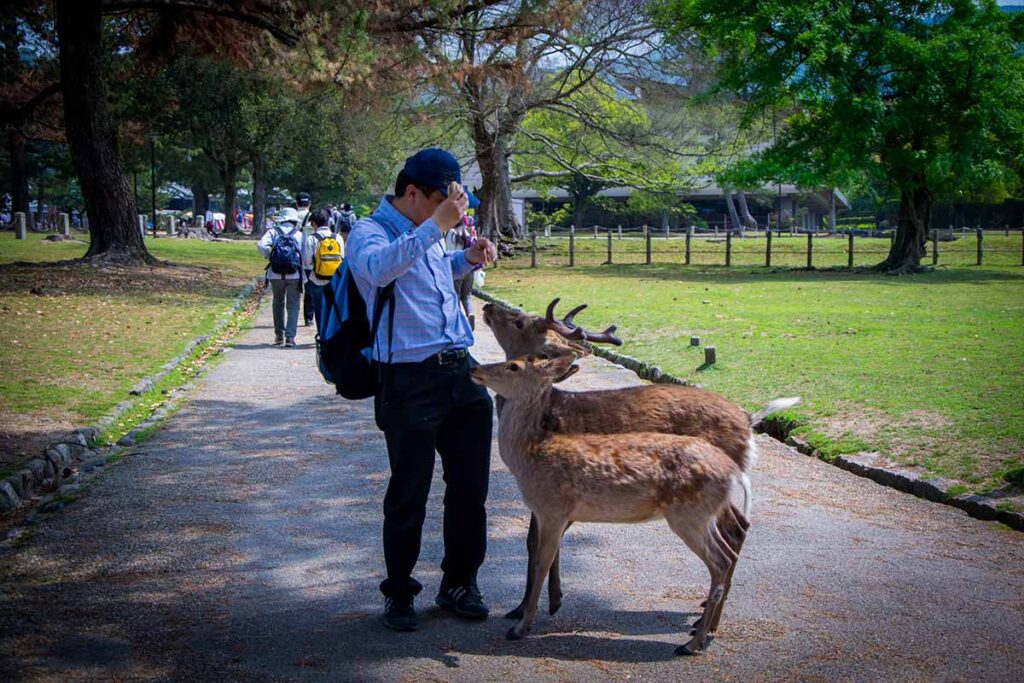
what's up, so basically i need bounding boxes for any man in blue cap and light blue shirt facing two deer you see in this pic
[346,148,498,631]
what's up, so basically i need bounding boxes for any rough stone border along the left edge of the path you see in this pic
[0,278,262,518]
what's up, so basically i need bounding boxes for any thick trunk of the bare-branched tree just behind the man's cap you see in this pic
[473,131,524,243]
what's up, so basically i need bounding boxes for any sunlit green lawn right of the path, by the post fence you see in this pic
[487,234,1024,497]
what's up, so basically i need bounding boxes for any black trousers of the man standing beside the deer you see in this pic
[374,357,493,596]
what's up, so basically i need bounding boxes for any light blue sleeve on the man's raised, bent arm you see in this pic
[347,220,441,287]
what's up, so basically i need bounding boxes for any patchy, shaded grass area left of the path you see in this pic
[0,232,264,464]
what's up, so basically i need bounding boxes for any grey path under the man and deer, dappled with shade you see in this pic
[0,299,1024,681]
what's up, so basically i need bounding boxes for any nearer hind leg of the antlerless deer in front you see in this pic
[666,516,732,655]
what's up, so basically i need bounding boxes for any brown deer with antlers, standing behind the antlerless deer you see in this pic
[483,298,799,626]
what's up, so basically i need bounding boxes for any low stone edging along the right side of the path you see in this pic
[473,290,1024,531]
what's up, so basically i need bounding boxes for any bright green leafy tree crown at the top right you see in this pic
[653,0,1024,201]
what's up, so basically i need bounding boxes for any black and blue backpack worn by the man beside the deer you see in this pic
[316,228,394,400]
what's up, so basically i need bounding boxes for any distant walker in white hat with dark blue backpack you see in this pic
[258,208,303,346]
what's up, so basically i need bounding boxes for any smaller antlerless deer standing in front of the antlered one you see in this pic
[471,356,750,654]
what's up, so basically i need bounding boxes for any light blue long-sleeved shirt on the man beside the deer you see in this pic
[345,196,474,362]
